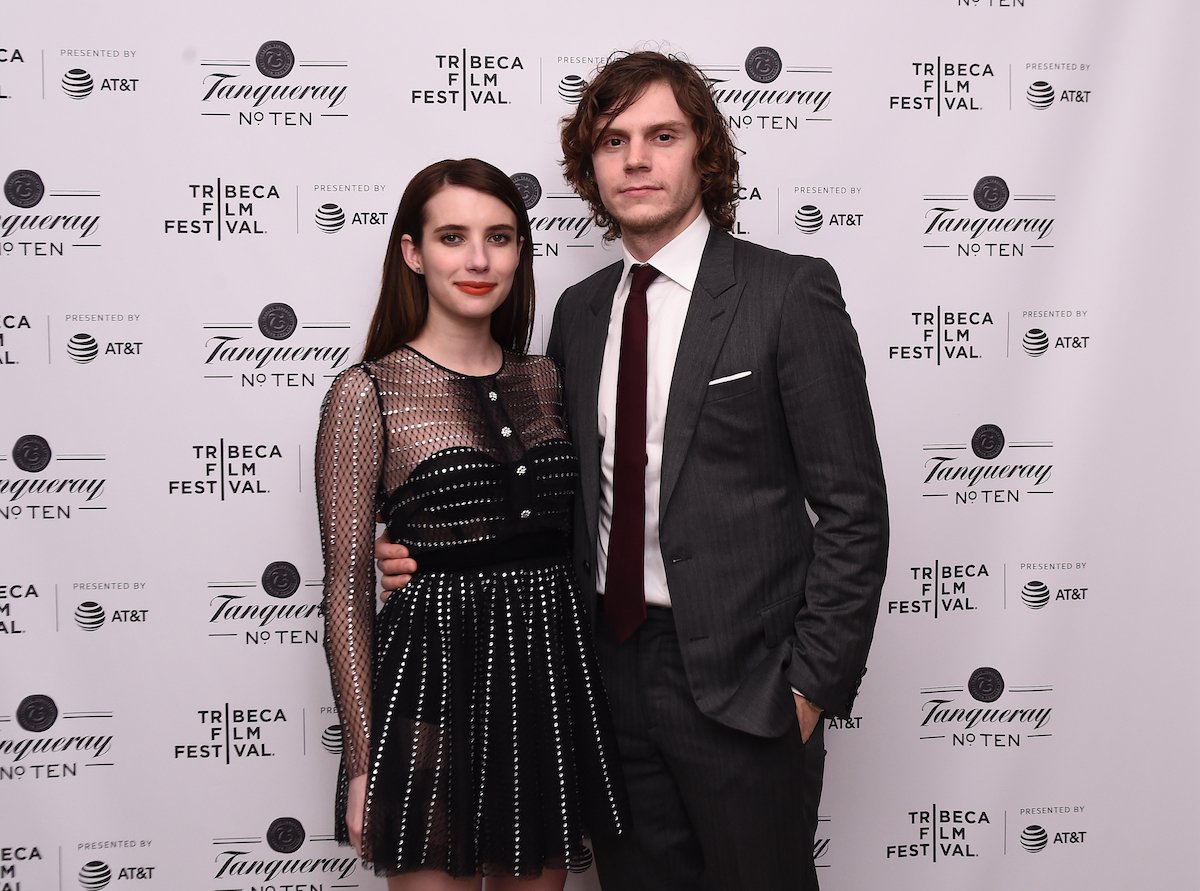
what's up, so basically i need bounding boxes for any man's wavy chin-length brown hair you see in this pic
[560,50,738,241]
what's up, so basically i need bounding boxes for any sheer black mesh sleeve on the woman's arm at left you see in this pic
[316,367,384,777]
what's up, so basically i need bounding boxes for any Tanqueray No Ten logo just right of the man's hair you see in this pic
[697,47,833,131]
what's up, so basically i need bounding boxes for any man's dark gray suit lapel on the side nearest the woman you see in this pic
[568,262,623,542]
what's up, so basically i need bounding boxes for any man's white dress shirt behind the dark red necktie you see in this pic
[596,213,710,606]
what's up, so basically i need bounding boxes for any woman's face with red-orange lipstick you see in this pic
[401,186,521,327]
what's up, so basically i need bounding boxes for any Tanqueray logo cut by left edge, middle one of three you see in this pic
[0,433,108,520]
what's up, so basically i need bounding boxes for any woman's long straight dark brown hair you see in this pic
[362,157,534,361]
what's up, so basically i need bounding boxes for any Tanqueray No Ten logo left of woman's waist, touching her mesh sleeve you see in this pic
[208,560,322,646]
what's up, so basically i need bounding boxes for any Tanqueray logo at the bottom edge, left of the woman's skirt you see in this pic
[212,817,359,891]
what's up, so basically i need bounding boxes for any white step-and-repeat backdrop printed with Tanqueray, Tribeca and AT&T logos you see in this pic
[0,0,1200,891]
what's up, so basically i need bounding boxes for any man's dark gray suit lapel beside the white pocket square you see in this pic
[659,229,743,524]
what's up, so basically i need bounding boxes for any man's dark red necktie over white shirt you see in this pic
[604,265,659,640]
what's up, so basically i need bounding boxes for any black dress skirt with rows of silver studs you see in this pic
[336,557,628,875]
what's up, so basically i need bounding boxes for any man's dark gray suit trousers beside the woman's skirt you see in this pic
[593,608,824,891]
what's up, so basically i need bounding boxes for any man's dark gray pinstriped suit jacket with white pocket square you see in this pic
[547,229,888,736]
